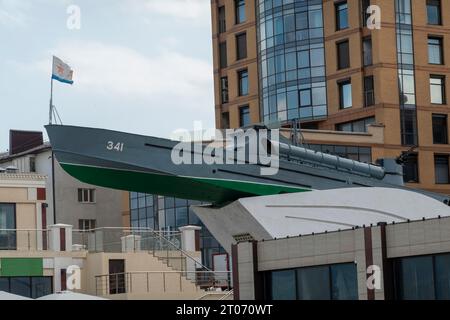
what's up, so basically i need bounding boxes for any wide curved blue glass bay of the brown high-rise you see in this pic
[257,0,327,123]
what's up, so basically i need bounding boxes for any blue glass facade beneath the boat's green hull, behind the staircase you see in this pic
[130,192,225,268]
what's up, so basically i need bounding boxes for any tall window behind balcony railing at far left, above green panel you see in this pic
[0,203,17,250]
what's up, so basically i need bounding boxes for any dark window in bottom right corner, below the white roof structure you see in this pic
[394,253,450,300]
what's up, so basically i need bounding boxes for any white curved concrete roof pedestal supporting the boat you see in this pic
[194,188,450,249]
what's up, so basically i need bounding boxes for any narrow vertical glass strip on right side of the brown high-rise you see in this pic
[395,0,418,146]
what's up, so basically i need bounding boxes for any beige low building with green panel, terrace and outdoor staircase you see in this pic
[0,169,232,300]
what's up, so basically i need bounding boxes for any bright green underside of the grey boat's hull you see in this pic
[61,163,310,204]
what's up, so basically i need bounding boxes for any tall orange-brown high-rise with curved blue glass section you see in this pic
[211,0,450,194]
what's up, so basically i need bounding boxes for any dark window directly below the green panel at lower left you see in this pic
[0,277,53,299]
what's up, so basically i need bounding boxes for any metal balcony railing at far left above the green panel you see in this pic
[0,229,50,251]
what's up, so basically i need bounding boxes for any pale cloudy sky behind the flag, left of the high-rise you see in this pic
[0,0,214,151]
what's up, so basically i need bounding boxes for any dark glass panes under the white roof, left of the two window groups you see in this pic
[266,263,358,300]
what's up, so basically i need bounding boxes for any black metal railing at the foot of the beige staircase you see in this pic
[95,271,231,296]
